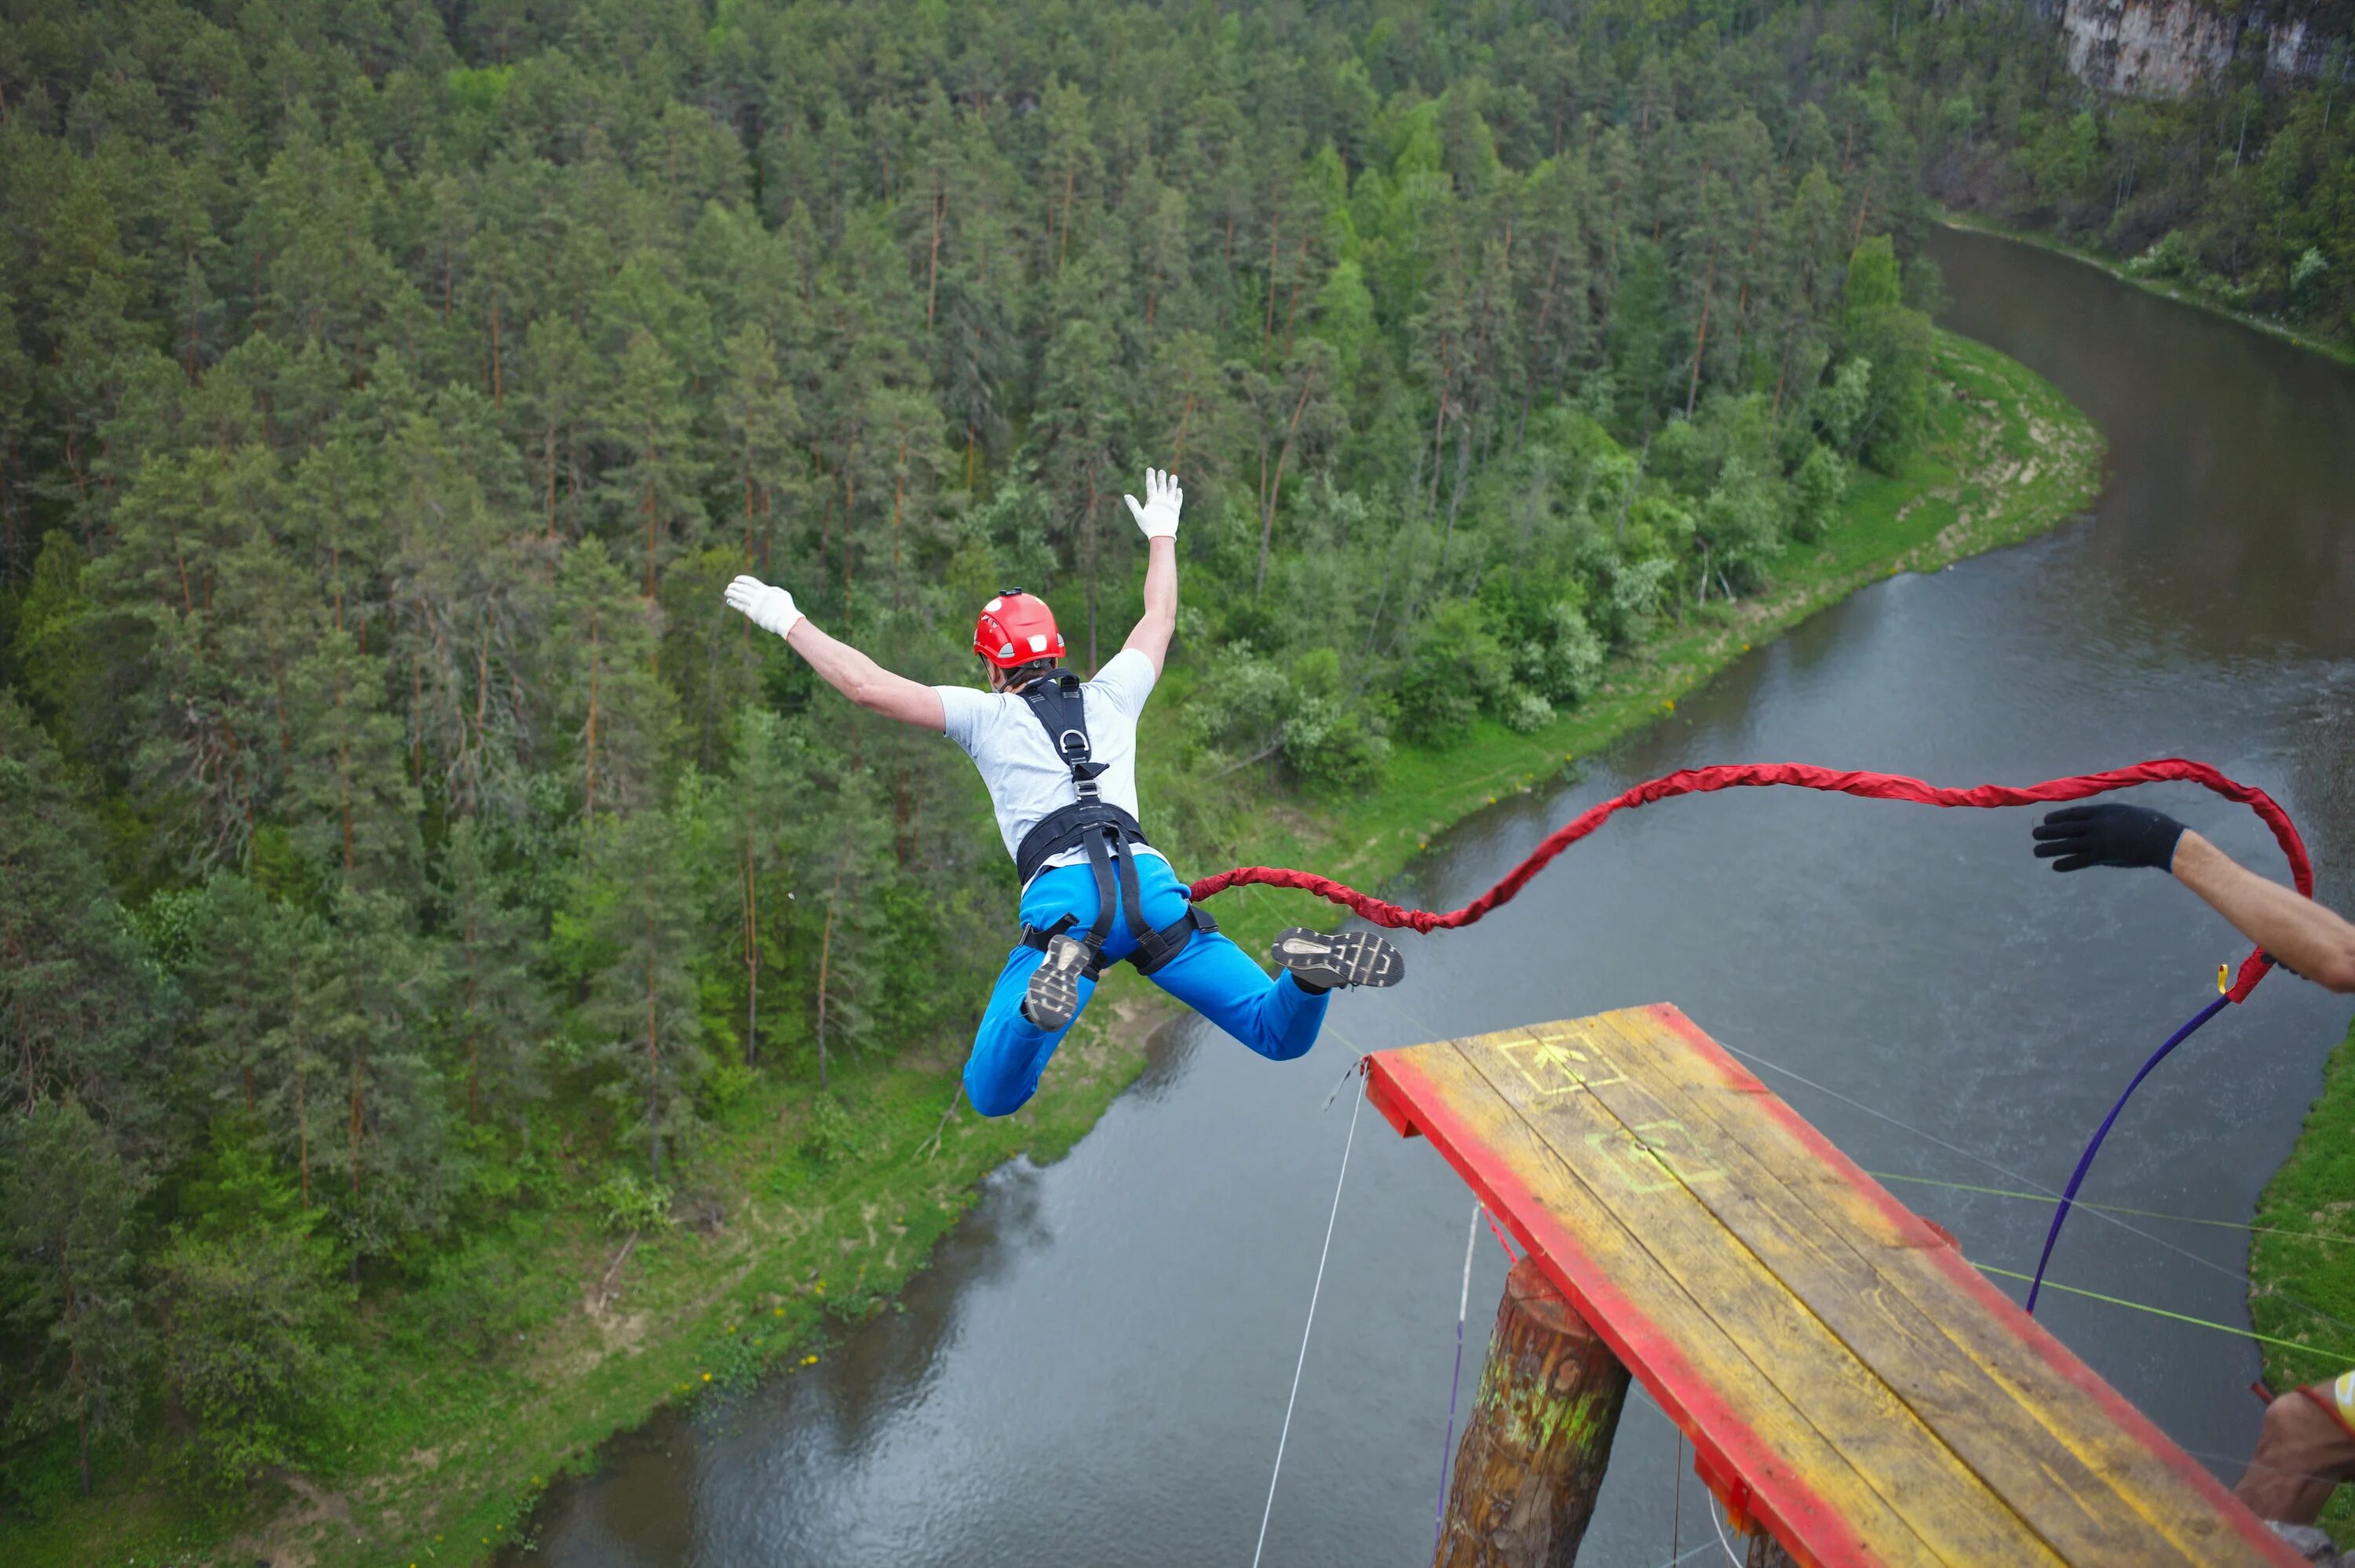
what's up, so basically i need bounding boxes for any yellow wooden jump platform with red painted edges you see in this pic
[1366,1005,2303,1568]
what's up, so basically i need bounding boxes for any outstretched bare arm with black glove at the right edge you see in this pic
[2035,805,2355,991]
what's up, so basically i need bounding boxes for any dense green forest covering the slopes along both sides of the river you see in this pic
[0,0,2355,1521]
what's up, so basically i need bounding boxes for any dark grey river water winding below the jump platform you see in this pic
[518,233,2355,1568]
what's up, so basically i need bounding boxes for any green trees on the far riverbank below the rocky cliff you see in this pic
[1889,5,2355,358]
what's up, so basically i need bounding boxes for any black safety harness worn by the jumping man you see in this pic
[1015,669,1218,984]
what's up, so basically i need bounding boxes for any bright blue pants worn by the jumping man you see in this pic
[966,855,1331,1116]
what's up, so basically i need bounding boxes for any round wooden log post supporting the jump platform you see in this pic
[1434,1257,1627,1568]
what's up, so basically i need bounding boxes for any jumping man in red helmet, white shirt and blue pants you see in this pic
[728,469,1406,1116]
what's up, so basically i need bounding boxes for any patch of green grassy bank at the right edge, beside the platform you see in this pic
[2249,1026,2355,1542]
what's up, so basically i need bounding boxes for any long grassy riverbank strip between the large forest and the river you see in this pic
[0,334,2110,1568]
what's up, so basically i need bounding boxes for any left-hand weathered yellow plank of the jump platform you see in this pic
[1411,1043,2058,1566]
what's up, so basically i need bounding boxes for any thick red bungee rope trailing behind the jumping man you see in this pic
[1192,756,2315,1003]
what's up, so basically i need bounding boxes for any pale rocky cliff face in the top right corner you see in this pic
[2056,0,2348,97]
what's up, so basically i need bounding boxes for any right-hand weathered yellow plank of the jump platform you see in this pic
[1500,1012,2221,1563]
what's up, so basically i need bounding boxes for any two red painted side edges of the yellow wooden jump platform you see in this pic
[1366,1003,2303,1568]
